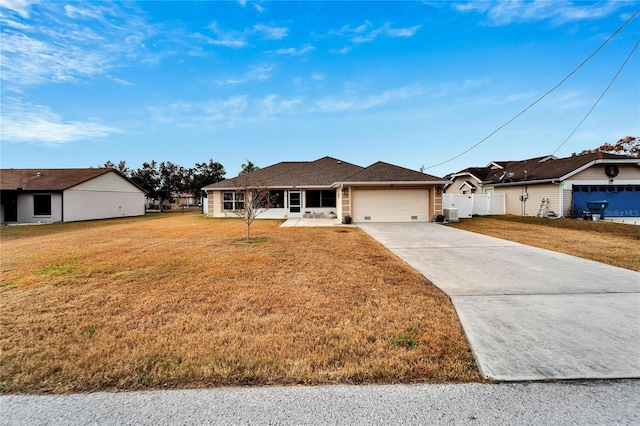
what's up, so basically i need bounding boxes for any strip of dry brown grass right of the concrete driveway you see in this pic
[448,216,640,272]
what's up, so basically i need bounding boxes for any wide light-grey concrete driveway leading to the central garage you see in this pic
[359,223,640,381]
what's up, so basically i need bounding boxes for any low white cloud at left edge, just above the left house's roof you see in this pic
[0,98,120,145]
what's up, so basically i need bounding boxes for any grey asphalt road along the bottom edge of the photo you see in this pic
[0,380,640,426]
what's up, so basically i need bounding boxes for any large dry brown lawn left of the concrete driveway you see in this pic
[0,214,480,393]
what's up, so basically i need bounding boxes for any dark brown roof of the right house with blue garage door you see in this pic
[451,152,640,185]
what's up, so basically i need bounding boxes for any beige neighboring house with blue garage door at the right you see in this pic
[445,152,640,218]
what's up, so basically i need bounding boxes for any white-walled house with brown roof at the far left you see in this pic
[0,168,145,223]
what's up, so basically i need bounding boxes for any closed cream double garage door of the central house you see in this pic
[352,189,429,222]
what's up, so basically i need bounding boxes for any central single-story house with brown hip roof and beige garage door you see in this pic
[203,157,448,222]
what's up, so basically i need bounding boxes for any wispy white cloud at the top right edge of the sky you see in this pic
[453,0,626,25]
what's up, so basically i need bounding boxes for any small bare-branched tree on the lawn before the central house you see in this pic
[234,175,275,243]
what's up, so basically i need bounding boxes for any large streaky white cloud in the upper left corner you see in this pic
[0,2,154,90]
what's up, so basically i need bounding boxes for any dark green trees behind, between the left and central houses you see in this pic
[103,159,259,203]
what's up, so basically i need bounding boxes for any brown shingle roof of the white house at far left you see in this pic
[0,168,129,191]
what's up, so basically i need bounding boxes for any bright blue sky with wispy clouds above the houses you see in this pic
[0,0,640,177]
